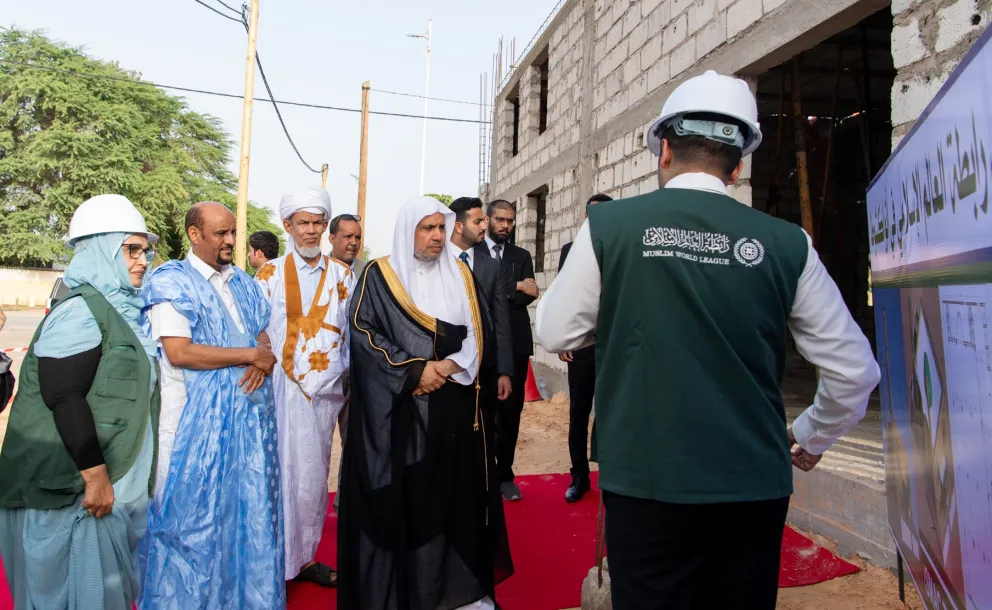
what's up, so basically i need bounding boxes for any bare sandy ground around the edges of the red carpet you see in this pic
[338,394,923,610]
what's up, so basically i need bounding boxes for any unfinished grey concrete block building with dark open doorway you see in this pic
[480,0,992,566]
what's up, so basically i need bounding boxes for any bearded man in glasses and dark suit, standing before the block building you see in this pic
[484,199,537,502]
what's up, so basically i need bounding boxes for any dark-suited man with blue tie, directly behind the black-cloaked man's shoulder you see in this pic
[448,197,513,402]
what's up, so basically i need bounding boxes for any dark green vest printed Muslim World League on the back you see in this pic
[589,189,808,504]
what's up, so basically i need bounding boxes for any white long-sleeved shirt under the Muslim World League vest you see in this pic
[535,173,879,455]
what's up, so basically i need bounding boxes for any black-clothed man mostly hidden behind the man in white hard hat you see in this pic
[558,194,613,502]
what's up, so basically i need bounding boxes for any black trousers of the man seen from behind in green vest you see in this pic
[603,492,789,610]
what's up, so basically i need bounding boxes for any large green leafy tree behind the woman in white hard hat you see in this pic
[0,29,282,265]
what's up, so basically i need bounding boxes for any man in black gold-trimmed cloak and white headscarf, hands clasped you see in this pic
[338,197,513,610]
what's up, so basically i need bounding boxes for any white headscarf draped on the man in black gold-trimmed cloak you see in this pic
[389,197,472,325]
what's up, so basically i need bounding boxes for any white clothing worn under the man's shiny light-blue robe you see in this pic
[149,252,244,496]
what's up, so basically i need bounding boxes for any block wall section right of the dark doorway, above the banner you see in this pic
[892,0,992,150]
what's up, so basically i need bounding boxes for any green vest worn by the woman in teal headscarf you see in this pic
[0,284,159,510]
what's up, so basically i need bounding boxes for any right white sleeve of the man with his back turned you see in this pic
[789,230,880,455]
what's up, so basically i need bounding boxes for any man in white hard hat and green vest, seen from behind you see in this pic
[536,71,879,610]
